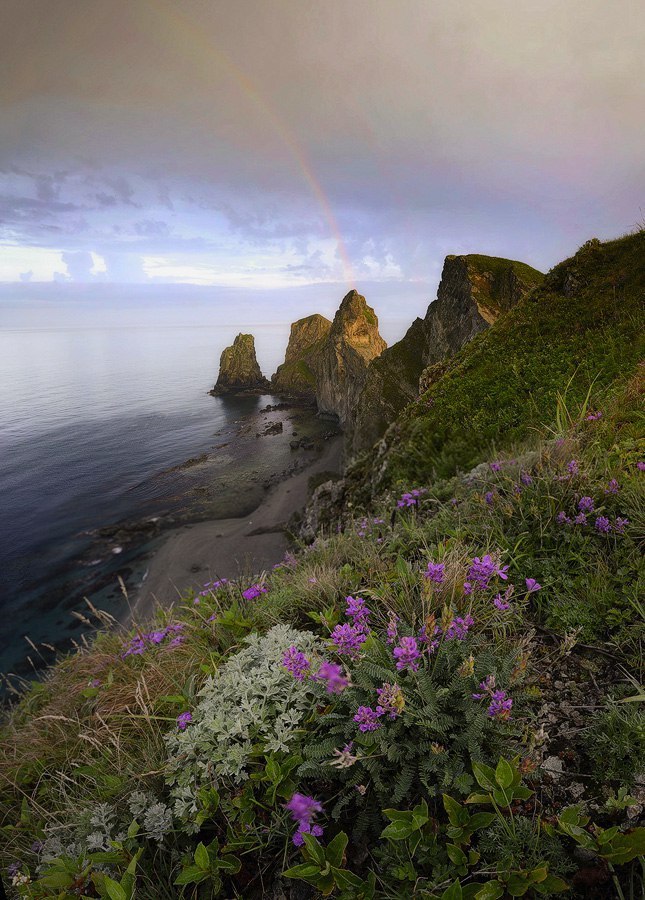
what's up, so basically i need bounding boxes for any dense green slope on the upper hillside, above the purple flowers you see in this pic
[355,232,645,489]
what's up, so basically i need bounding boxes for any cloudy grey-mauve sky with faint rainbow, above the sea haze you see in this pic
[0,0,645,289]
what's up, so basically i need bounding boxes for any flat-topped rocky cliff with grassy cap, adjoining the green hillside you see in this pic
[348,255,544,453]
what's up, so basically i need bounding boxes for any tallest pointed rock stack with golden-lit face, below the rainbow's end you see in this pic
[314,291,387,425]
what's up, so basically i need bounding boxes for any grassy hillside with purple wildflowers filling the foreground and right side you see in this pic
[0,235,645,900]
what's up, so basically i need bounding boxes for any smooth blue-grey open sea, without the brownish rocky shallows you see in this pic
[0,325,288,671]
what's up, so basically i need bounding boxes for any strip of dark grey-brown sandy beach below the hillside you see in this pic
[132,435,343,622]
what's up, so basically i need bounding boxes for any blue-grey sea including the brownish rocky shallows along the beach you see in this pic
[0,326,330,675]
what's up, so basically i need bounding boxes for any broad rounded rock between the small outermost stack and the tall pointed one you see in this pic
[271,313,331,397]
